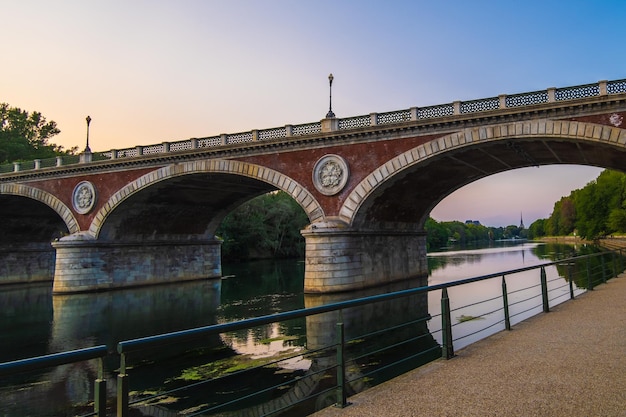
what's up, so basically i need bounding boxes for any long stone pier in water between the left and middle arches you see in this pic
[52,233,222,293]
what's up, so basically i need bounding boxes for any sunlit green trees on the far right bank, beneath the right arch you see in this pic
[529,170,626,240]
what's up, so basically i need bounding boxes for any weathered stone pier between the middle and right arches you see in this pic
[302,221,428,293]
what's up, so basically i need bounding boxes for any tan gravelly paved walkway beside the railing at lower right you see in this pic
[314,274,626,417]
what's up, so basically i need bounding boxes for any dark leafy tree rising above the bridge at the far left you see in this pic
[0,103,76,163]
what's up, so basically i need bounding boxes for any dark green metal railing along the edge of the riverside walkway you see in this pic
[0,251,624,417]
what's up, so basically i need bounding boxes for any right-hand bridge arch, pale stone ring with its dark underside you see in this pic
[339,119,626,229]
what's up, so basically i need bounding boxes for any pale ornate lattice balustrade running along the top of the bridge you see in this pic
[0,79,626,174]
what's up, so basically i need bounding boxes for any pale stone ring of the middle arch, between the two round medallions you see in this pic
[88,160,324,239]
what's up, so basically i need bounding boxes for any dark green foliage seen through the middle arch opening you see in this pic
[216,191,309,260]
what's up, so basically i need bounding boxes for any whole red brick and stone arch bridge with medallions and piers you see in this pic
[0,80,626,293]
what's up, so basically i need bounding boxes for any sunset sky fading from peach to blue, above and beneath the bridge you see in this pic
[0,0,626,226]
